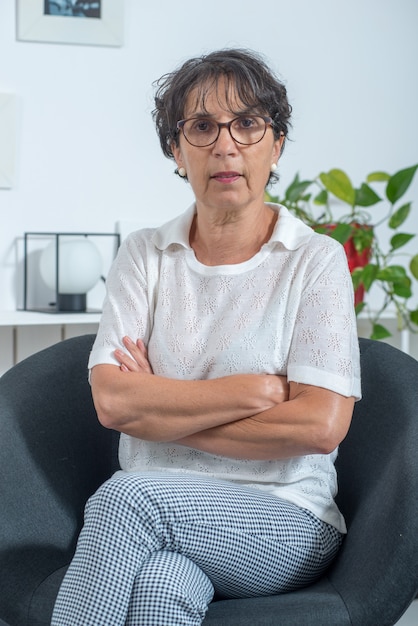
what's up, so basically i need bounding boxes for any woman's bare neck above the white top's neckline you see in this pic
[190,204,277,266]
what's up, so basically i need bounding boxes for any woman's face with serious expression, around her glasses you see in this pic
[173,77,284,210]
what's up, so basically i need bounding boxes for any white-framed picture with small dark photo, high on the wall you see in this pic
[16,0,123,46]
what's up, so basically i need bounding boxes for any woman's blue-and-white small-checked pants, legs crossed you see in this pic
[51,472,341,626]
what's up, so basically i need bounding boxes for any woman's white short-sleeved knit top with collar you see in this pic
[89,204,361,532]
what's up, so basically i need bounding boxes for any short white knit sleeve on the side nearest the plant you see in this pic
[288,235,361,400]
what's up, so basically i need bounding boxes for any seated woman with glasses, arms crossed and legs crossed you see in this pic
[52,50,360,626]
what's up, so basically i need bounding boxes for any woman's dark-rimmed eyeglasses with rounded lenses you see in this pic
[177,115,273,148]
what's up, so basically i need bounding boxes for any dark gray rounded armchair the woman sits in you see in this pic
[0,335,418,626]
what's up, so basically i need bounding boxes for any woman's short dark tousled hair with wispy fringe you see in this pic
[152,48,292,178]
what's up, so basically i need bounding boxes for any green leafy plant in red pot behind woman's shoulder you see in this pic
[266,165,418,339]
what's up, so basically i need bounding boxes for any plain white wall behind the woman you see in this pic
[0,0,418,352]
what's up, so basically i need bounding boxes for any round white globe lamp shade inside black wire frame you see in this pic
[40,236,102,302]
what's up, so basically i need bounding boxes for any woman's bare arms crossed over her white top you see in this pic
[91,338,354,460]
